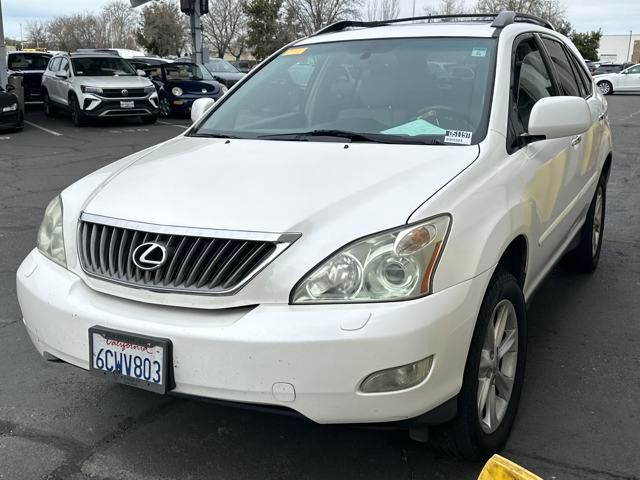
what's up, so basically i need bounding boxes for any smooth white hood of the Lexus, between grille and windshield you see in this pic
[84,137,479,235]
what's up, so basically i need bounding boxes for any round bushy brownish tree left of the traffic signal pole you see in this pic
[137,0,187,57]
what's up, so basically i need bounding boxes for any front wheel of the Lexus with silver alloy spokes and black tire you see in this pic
[429,267,527,462]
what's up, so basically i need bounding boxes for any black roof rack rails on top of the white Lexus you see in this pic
[311,10,555,37]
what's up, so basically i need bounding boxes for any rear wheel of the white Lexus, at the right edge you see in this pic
[562,174,607,273]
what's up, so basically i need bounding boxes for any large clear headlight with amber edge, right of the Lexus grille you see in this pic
[291,215,451,303]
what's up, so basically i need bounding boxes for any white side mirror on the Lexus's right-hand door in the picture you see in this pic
[529,97,592,143]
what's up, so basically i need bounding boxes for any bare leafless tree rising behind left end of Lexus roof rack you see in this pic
[288,0,363,35]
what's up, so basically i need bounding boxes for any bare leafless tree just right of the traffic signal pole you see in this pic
[202,0,246,58]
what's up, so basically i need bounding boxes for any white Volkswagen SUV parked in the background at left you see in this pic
[42,52,158,127]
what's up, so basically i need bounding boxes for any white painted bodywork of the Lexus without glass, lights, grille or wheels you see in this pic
[18,23,612,423]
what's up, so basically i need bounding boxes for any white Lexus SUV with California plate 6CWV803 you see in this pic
[17,12,612,459]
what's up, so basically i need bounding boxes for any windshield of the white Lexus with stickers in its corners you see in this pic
[194,38,495,145]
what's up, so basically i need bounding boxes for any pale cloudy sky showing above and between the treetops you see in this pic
[0,0,640,38]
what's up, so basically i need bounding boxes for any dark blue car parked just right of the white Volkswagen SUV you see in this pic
[144,62,227,117]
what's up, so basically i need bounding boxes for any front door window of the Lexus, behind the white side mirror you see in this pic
[509,38,557,141]
